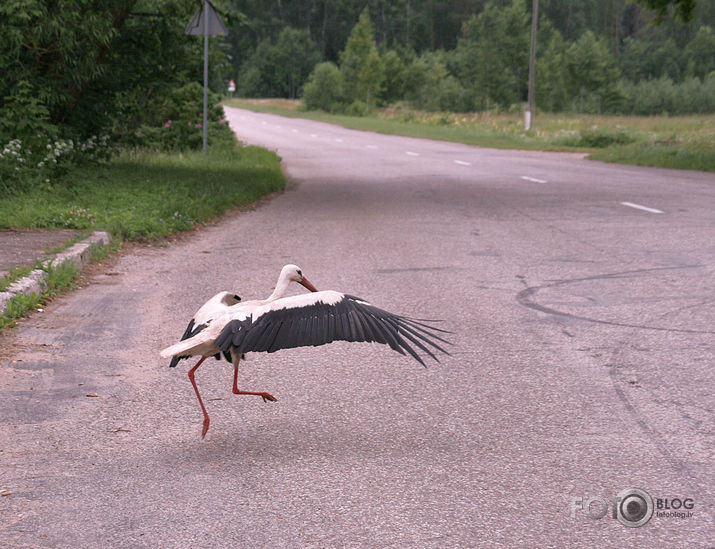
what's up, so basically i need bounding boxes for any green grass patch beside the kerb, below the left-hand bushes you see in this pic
[0,146,285,240]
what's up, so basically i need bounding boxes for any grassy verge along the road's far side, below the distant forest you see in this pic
[226,99,715,172]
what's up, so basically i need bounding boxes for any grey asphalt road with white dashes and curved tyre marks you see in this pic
[0,105,715,548]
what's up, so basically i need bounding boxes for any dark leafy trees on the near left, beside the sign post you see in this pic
[0,0,218,140]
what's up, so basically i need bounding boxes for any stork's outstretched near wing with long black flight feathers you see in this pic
[215,295,449,365]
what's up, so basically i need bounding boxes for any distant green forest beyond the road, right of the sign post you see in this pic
[229,0,715,114]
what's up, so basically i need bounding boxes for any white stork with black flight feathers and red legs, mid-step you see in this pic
[161,265,449,438]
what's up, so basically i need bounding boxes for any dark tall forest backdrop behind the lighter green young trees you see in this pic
[229,0,715,62]
